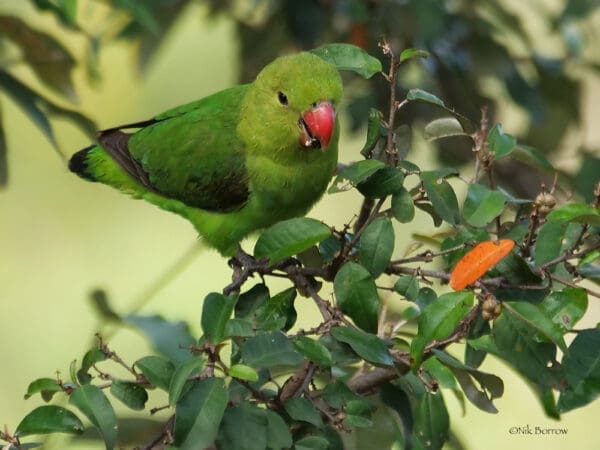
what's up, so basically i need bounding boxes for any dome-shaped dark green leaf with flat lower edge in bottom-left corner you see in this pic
[15,405,83,437]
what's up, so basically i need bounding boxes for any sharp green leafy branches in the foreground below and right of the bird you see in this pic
[0,42,600,449]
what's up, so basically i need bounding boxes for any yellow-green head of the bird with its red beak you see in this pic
[238,53,342,156]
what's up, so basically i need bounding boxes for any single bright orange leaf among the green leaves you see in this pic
[450,239,515,291]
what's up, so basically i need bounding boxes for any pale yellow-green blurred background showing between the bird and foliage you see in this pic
[0,1,600,450]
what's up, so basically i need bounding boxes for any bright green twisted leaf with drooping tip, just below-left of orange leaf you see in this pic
[410,291,473,369]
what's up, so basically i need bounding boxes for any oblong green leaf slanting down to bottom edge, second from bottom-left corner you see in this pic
[69,384,117,450]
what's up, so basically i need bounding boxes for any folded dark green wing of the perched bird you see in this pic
[99,85,249,212]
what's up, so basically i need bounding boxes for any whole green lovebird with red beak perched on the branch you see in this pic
[69,52,342,256]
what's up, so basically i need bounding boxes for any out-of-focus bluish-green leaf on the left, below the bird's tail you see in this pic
[124,314,196,363]
